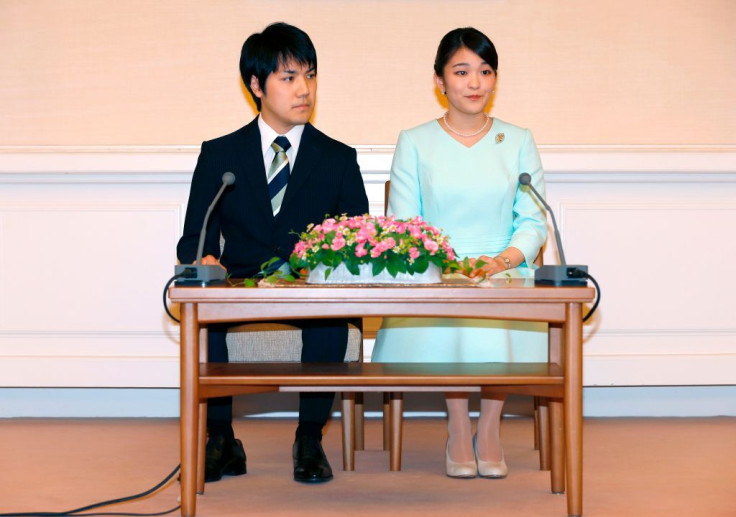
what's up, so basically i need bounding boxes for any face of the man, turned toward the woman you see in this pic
[250,60,317,135]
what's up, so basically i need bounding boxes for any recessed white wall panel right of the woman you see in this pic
[561,201,736,330]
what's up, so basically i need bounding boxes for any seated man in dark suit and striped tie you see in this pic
[177,23,368,483]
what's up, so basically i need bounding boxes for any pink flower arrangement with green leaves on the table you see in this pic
[290,214,458,279]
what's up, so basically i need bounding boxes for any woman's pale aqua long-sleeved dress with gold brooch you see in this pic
[372,118,547,363]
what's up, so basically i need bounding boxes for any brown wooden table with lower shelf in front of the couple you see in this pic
[169,279,594,517]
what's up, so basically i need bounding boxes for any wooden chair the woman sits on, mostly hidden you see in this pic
[383,180,551,470]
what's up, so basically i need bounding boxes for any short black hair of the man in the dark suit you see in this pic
[240,22,317,111]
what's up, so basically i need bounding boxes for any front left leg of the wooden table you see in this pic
[179,303,199,517]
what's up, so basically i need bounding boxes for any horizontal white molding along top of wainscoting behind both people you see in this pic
[0,145,736,183]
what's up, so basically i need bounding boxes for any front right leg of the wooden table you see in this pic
[565,303,583,517]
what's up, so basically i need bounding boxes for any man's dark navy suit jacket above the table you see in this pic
[177,119,368,278]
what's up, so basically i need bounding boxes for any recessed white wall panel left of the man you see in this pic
[0,204,180,332]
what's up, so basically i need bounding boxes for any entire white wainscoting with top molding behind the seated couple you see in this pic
[0,146,736,388]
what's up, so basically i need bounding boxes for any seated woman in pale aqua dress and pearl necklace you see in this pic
[373,28,547,478]
